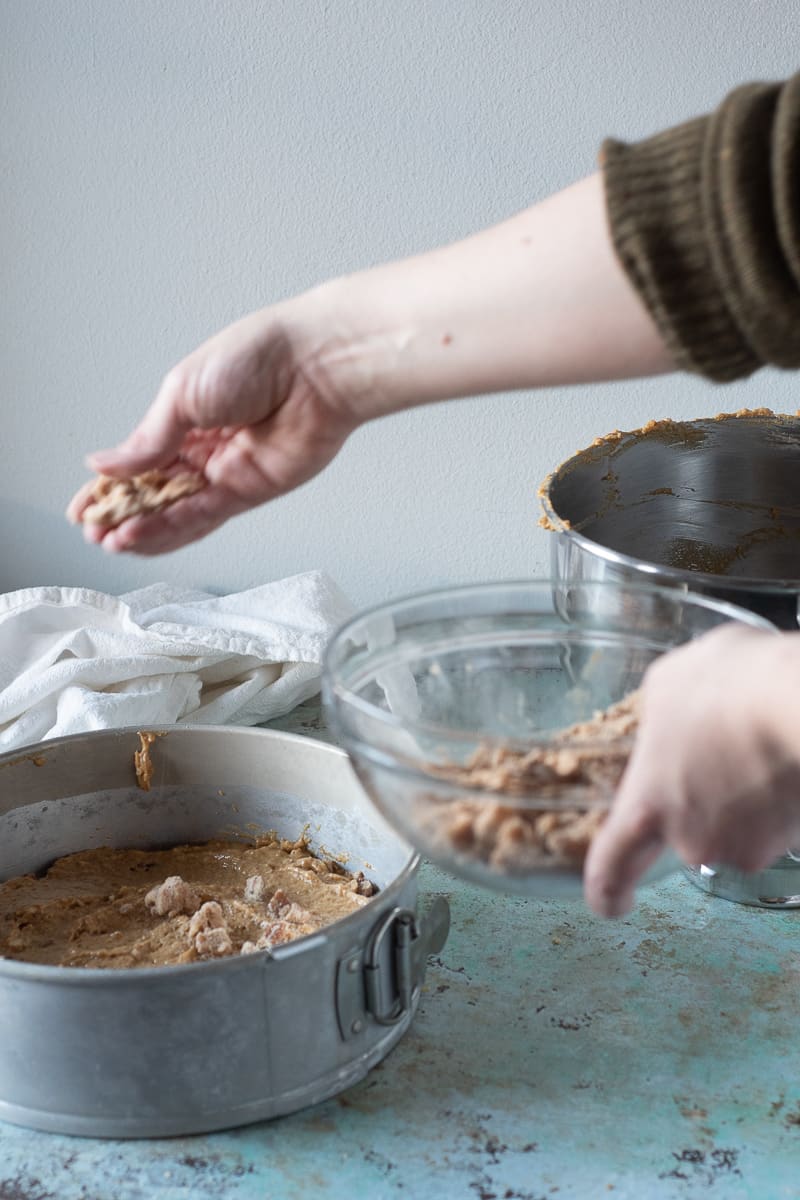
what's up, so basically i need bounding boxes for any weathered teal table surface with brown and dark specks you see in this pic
[0,703,800,1200]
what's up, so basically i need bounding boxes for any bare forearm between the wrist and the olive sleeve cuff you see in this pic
[295,175,672,421]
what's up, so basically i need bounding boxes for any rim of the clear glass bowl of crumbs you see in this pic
[321,576,781,748]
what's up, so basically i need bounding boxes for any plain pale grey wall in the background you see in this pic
[0,0,800,602]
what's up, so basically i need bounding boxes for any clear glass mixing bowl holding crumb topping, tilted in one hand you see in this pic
[323,580,772,896]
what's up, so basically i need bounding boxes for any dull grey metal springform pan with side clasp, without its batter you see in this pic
[0,725,449,1138]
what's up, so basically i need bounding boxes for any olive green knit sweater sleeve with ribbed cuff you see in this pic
[601,74,800,383]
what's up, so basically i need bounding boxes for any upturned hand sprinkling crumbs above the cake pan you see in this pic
[67,293,359,554]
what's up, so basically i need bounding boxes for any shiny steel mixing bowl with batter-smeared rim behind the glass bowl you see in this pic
[541,409,800,629]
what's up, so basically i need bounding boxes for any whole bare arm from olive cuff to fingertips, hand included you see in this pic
[68,176,670,553]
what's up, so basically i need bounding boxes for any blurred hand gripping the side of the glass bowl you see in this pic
[584,625,800,917]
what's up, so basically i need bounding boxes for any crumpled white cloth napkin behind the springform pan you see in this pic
[0,571,353,750]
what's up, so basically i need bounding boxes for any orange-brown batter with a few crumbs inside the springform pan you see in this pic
[0,836,377,967]
